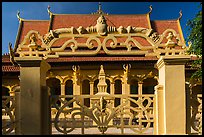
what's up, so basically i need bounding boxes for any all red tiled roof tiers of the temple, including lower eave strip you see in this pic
[2,4,191,72]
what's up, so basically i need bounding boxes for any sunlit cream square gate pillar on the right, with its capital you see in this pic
[155,56,190,134]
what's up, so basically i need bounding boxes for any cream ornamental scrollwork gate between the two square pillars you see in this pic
[51,94,155,134]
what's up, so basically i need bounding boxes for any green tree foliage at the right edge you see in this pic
[187,3,202,80]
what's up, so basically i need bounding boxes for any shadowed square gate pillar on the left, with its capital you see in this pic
[15,57,51,135]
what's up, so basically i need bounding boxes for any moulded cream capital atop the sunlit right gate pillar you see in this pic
[155,55,191,69]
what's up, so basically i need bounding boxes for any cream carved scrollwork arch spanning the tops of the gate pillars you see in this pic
[17,26,186,58]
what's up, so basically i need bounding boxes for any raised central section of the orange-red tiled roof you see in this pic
[51,14,149,30]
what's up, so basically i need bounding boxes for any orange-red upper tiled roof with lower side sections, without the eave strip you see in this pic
[15,14,186,53]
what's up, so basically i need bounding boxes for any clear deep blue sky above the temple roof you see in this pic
[2,2,200,54]
